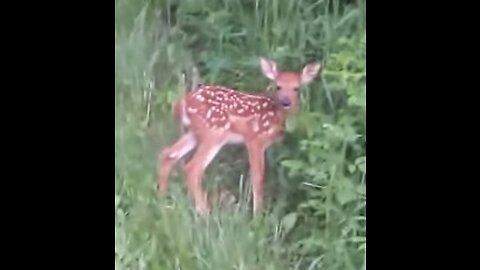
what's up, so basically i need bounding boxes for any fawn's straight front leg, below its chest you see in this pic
[247,140,265,212]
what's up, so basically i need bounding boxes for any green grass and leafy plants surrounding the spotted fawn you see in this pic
[115,0,366,270]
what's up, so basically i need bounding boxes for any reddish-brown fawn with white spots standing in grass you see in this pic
[158,58,320,215]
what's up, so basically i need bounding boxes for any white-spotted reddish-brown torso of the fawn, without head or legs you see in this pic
[180,85,283,141]
